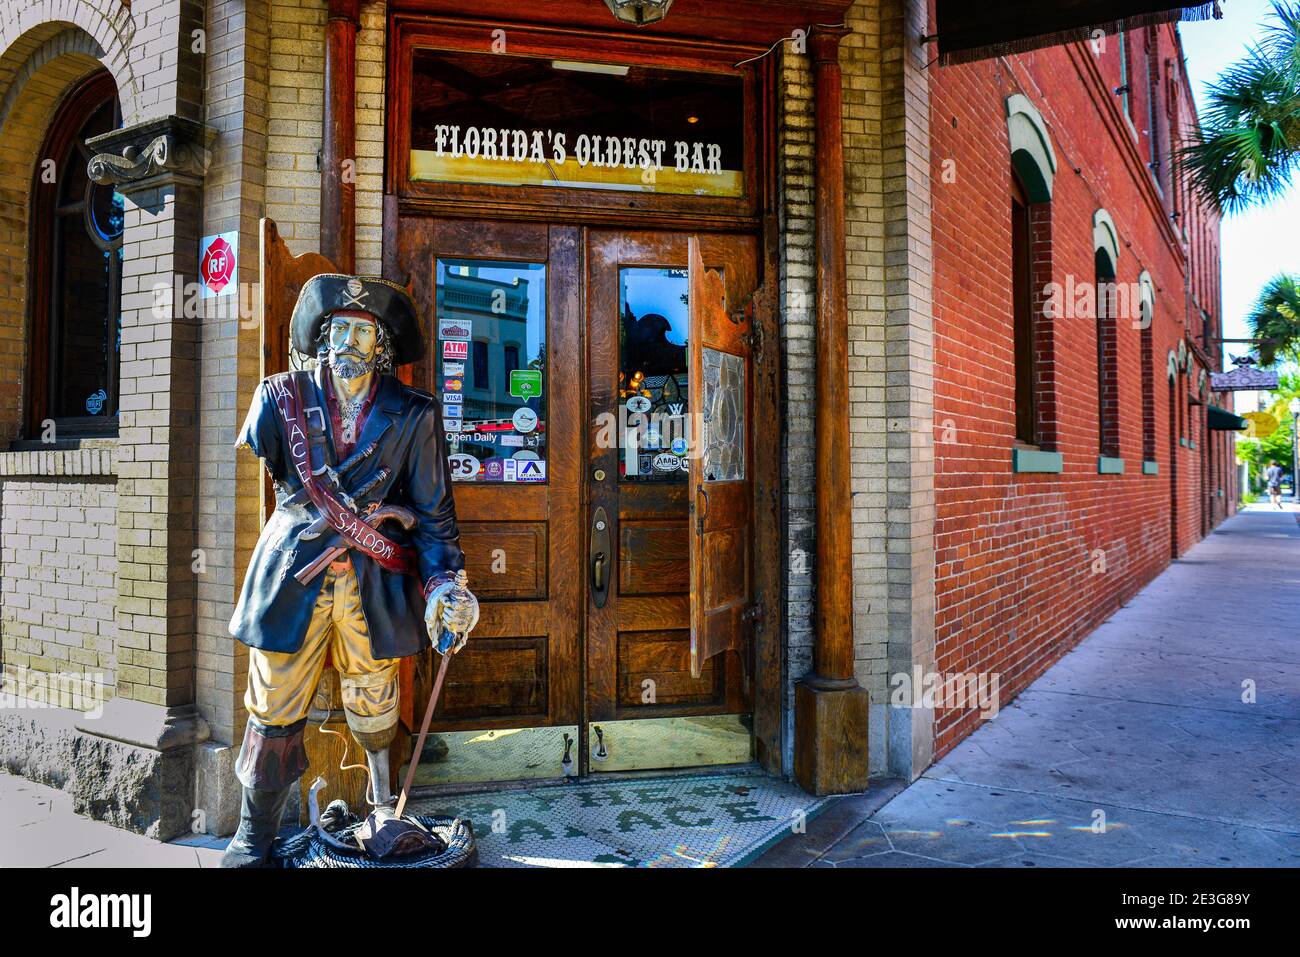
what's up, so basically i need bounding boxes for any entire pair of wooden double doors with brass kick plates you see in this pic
[400,218,759,784]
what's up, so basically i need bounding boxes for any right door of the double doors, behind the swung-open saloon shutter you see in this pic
[585,230,757,771]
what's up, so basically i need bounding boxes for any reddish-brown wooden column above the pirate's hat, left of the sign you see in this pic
[321,0,359,273]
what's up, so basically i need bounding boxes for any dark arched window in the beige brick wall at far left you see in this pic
[27,72,124,441]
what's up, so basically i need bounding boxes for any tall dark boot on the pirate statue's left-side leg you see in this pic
[221,718,307,867]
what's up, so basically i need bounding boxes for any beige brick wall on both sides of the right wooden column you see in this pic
[779,0,933,775]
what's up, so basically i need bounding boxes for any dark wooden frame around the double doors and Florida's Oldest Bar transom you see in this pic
[382,0,790,774]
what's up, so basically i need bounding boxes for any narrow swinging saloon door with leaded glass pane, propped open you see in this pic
[689,237,754,677]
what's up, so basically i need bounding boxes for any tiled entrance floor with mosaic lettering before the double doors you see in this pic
[411,772,827,867]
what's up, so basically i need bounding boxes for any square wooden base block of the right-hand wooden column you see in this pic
[794,679,868,797]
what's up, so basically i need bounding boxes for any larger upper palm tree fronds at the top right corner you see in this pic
[1179,0,1300,212]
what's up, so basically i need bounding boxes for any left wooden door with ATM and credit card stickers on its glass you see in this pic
[402,218,582,743]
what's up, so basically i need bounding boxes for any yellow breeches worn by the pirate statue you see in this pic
[244,559,400,740]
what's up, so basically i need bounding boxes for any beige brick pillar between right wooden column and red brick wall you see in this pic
[840,0,935,775]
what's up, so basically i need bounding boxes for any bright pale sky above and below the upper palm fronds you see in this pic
[1179,0,1300,368]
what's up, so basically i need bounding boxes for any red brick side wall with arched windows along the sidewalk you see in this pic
[931,18,1235,757]
